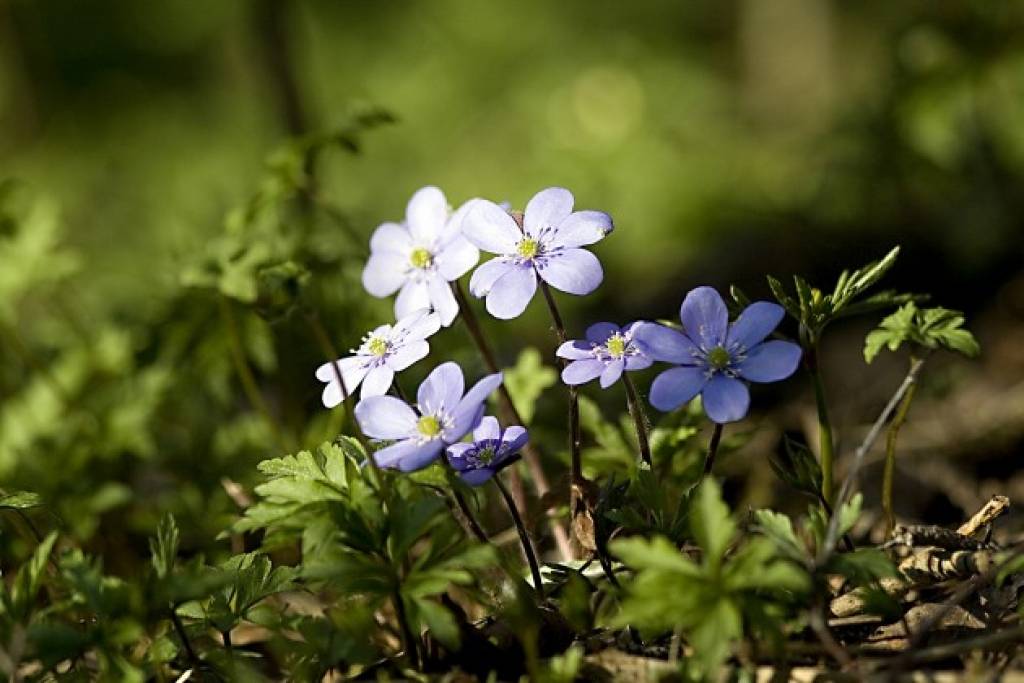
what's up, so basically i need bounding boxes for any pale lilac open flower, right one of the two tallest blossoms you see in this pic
[462,187,612,319]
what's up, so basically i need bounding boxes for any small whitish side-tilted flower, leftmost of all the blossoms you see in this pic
[316,308,441,408]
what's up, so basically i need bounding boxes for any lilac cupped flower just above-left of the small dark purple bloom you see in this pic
[355,362,502,472]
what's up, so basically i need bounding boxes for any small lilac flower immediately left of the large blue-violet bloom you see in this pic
[557,323,653,389]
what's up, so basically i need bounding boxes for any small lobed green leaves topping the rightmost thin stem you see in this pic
[864,301,981,362]
